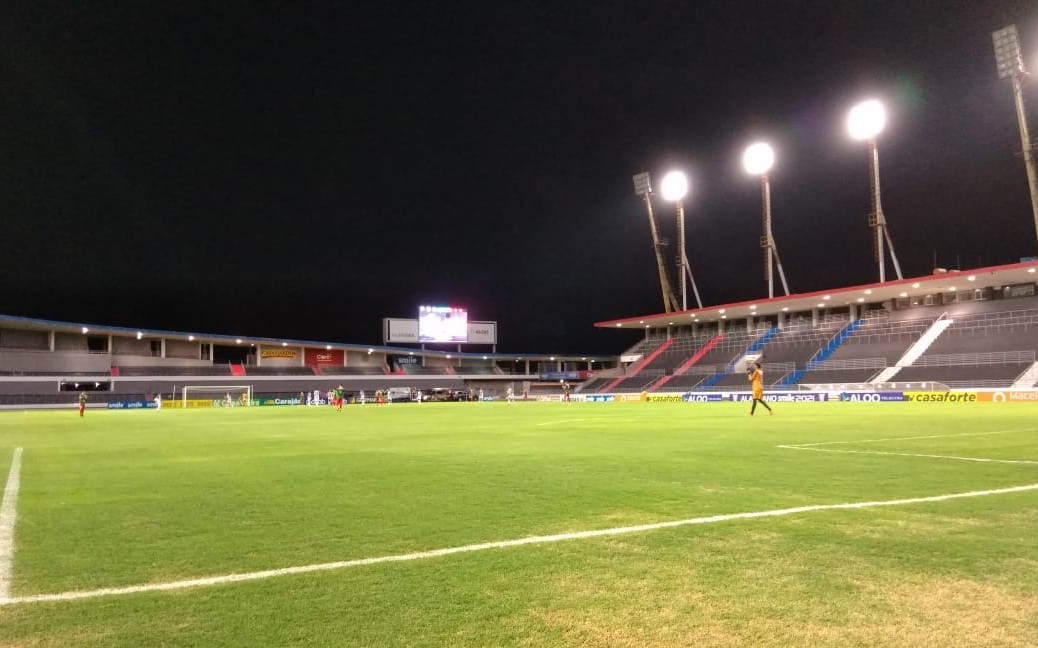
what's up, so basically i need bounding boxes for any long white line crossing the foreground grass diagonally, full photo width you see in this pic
[0,484,1038,605]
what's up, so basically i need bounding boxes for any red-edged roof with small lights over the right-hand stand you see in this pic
[595,261,1038,329]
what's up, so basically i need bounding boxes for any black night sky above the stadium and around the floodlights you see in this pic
[0,0,1038,353]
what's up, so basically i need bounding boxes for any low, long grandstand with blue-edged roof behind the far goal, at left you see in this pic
[0,315,619,408]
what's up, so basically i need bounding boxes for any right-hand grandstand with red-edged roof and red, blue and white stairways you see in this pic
[593,260,1038,394]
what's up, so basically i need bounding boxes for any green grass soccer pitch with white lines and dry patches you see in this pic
[0,403,1038,647]
